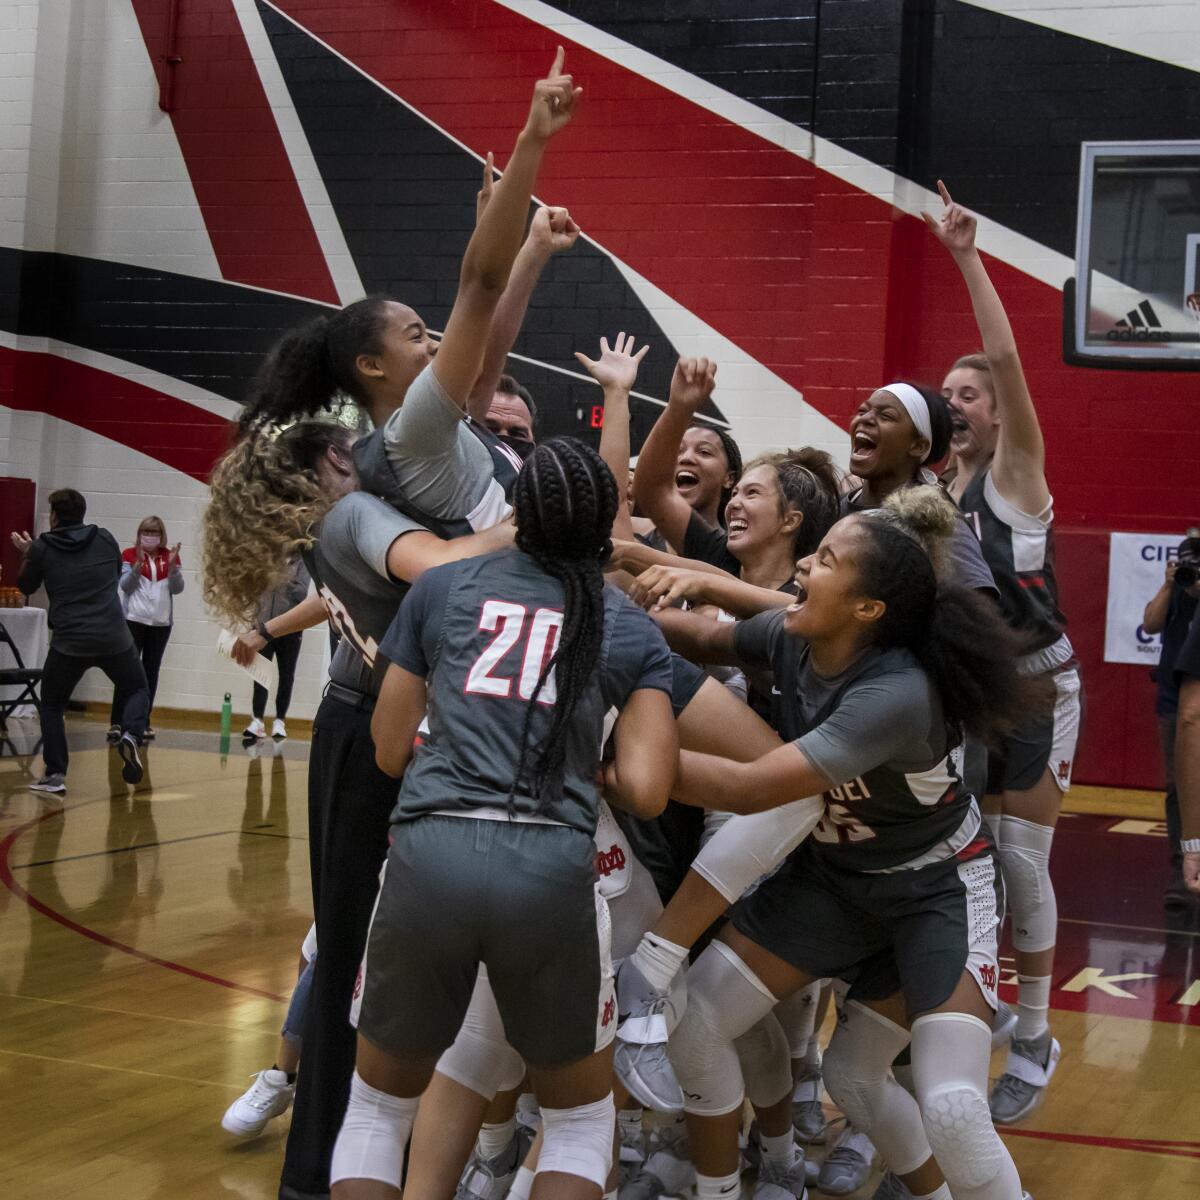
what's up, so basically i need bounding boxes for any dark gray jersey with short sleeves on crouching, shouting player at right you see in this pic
[734,610,979,871]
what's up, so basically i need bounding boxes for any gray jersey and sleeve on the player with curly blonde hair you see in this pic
[304,492,424,696]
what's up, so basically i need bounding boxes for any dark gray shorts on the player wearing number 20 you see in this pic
[358,816,617,1067]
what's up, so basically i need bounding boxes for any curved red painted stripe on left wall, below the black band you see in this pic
[0,347,233,482]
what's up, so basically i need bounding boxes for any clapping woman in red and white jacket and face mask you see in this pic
[108,517,184,742]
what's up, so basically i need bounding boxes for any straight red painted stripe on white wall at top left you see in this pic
[133,0,338,304]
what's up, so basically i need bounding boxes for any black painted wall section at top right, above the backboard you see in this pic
[542,0,1200,256]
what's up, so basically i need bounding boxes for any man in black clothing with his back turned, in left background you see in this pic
[12,487,150,793]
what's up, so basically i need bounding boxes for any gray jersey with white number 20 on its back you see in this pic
[380,550,673,836]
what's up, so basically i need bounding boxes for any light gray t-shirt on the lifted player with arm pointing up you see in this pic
[383,364,511,529]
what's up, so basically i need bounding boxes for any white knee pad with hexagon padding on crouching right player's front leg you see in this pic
[912,1013,1021,1200]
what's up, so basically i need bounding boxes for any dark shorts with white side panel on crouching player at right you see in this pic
[731,827,1004,1018]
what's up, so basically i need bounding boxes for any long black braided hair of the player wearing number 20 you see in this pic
[509,438,618,810]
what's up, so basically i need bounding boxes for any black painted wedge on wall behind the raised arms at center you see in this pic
[258,2,720,446]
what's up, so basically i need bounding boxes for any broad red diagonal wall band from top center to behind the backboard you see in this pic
[267,0,1200,529]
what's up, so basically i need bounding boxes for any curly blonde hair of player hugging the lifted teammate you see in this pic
[203,421,353,629]
